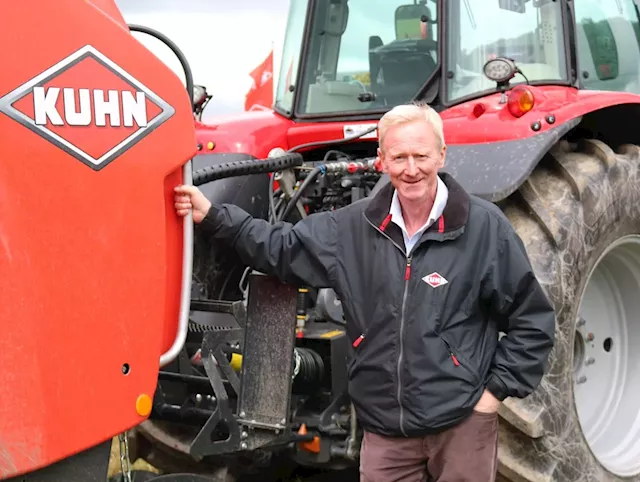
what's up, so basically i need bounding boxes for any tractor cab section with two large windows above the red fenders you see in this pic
[275,0,571,119]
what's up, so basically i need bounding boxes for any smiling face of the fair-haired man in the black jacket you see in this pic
[378,121,446,201]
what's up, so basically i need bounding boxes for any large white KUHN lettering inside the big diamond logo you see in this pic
[33,87,147,127]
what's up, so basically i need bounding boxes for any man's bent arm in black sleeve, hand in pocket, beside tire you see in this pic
[483,221,556,400]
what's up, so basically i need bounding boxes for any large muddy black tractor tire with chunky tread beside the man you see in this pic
[498,139,640,482]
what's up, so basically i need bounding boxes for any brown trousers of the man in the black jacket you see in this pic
[360,411,498,482]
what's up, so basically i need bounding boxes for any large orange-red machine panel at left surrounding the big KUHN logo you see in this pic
[0,0,196,479]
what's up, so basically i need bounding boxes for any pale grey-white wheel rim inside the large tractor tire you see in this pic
[573,235,640,477]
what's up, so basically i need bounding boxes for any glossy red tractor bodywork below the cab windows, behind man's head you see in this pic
[198,86,640,157]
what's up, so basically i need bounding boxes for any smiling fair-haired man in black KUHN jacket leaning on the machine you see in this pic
[175,105,555,482]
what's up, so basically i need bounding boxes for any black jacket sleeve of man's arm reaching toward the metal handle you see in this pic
[200,204,337,288]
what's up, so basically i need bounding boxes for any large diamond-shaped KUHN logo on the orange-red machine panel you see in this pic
[0,45,175,171]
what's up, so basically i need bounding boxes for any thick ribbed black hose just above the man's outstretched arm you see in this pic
[193,153,304,186]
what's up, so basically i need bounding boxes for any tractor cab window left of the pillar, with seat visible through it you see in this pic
[275,0,438,115]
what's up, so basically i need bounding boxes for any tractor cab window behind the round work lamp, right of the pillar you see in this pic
[445,0,568,103]
